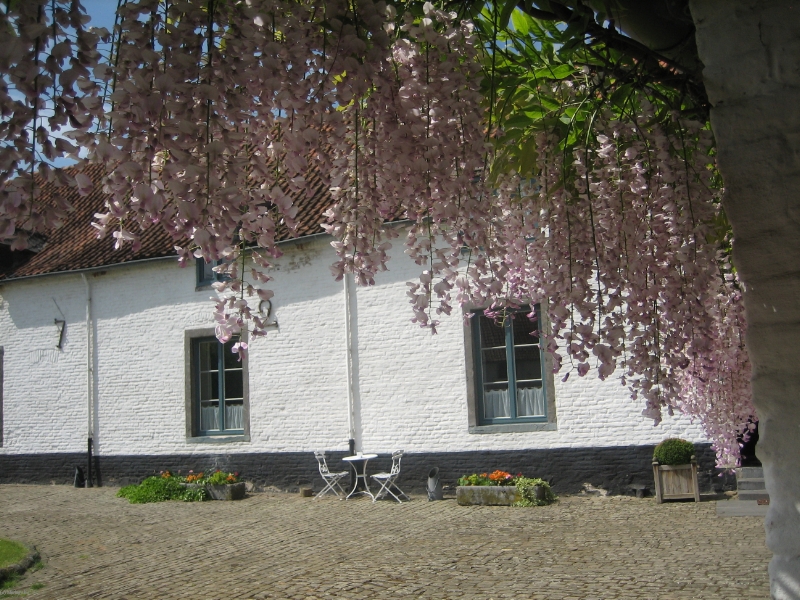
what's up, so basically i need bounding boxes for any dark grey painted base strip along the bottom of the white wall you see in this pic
[0,444,736,494]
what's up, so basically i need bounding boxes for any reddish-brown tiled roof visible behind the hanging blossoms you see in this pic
[0,165,332,280]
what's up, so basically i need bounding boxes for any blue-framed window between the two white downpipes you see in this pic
[192,337,245,435]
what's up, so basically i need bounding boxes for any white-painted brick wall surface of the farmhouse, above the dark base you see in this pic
[0,238,705,455]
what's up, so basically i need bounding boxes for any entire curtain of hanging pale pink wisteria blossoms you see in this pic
[0,0,753,464]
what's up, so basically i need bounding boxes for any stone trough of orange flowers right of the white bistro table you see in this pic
[456,470,556,506]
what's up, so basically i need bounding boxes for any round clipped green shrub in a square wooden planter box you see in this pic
[653,438,700,504]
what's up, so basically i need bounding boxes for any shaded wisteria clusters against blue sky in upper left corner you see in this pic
[0,0,109,250]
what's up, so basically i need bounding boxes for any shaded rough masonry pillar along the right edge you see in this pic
[691,0,800,600]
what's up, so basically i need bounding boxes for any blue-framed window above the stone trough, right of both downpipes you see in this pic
[472,304,547,425]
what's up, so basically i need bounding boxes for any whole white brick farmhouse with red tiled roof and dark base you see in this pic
[0,167,722,493]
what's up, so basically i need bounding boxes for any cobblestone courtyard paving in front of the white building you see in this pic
[0,485,770,600]
